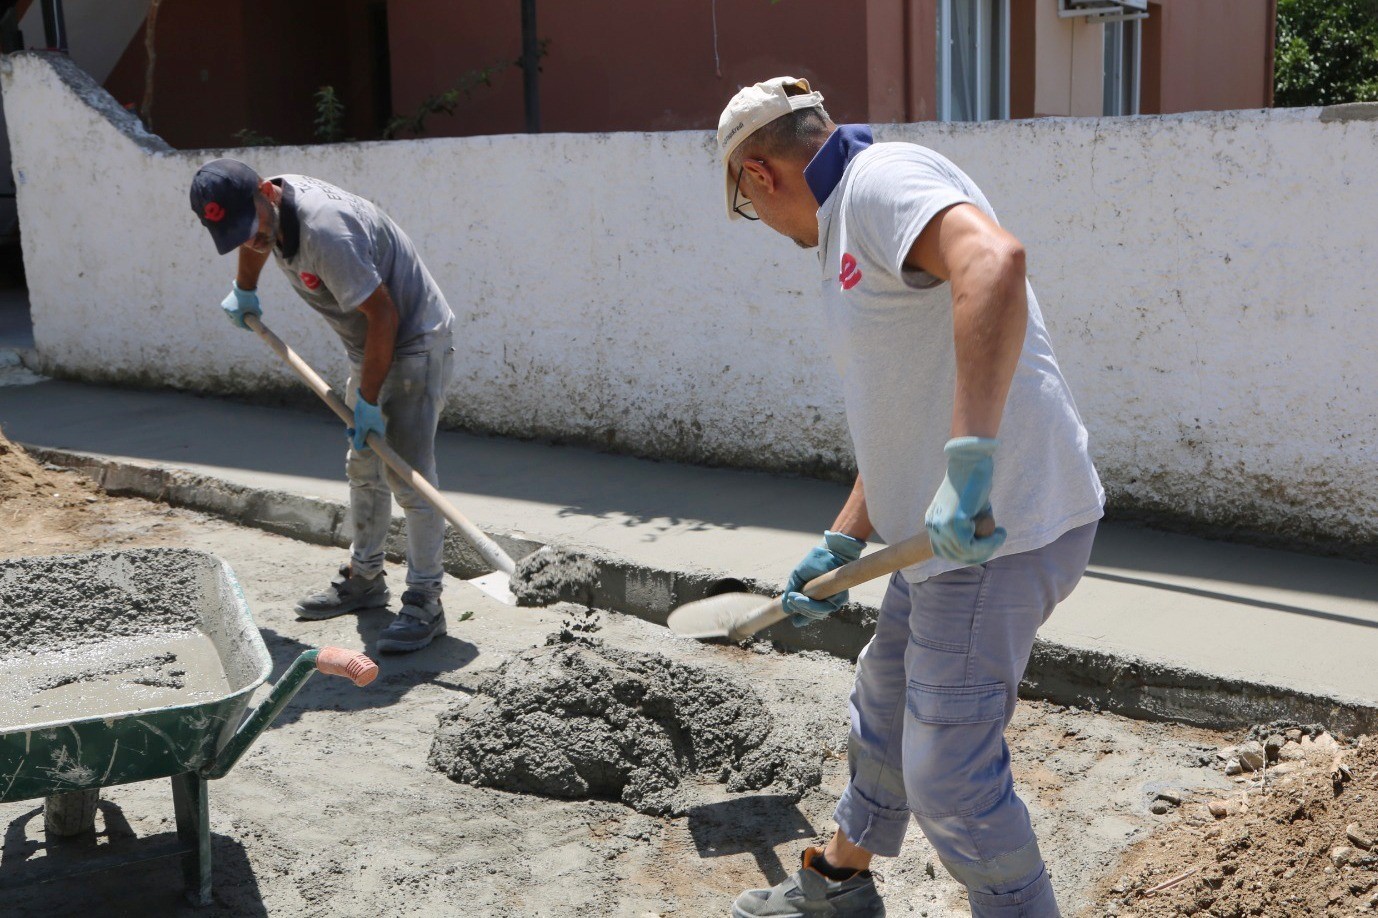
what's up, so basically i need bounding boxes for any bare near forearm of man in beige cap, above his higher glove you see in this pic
[951,248,1028,437]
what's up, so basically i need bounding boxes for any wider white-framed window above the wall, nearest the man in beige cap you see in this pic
[937,0,1010,121]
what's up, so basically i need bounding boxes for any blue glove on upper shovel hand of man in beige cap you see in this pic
[923,437,1005,565]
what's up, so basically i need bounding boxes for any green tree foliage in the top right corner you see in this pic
[1273,0,1378,106]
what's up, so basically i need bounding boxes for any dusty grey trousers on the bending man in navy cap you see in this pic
[345,332,455,598]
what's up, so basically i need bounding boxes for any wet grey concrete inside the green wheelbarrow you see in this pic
[0,549,230,729]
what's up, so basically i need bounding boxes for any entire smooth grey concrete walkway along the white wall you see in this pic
[0,382,1378,704]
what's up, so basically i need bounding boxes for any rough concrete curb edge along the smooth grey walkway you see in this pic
[25,445,1378,735]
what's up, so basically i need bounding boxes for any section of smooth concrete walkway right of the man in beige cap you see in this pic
[1040,525,1378,700]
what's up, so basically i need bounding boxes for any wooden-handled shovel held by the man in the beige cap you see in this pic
[667,516,995,641]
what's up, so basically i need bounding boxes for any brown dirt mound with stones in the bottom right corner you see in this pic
[1089,724,1378,917]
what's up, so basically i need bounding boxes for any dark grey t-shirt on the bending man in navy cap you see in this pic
[271,175,455,364]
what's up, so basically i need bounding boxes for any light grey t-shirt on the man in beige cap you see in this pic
[819,143,1105,583]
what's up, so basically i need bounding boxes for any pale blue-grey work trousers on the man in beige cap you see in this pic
[835,522,1097,918]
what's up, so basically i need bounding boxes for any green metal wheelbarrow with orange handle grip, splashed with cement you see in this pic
[0,549,378,904]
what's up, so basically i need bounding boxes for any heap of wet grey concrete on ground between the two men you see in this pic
[430,633,823,816]
